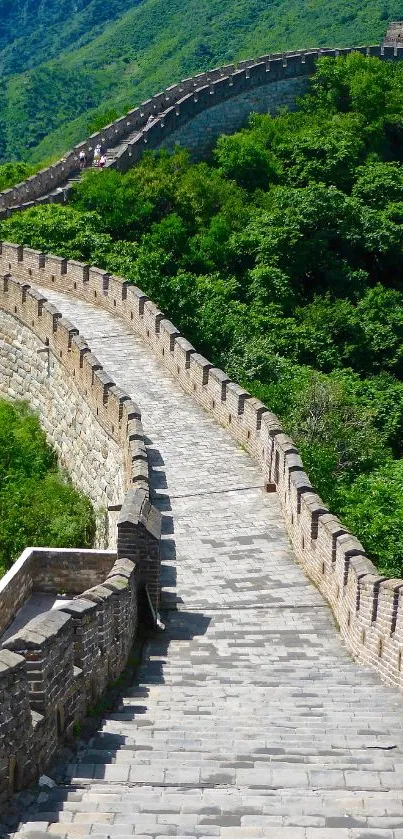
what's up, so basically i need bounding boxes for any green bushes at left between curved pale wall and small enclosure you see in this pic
[0,400,95,575]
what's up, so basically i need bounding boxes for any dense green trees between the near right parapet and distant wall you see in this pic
[0,53,403,576]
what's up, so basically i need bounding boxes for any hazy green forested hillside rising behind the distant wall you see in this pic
[0,0,401,162]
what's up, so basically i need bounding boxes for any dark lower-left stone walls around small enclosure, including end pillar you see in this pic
[0,488,161,809]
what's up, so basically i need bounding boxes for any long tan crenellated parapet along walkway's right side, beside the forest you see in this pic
[0,243,403,687]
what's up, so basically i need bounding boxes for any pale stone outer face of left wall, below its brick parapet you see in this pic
[0,311,127,548]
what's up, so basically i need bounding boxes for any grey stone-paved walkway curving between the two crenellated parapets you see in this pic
[10,290,403,839]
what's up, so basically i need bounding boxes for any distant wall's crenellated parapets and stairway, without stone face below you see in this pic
[0,45,403,214]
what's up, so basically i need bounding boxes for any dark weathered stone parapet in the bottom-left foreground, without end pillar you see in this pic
[0,559,140,807]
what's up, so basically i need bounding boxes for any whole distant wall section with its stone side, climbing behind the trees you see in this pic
[0,44,403,214]
